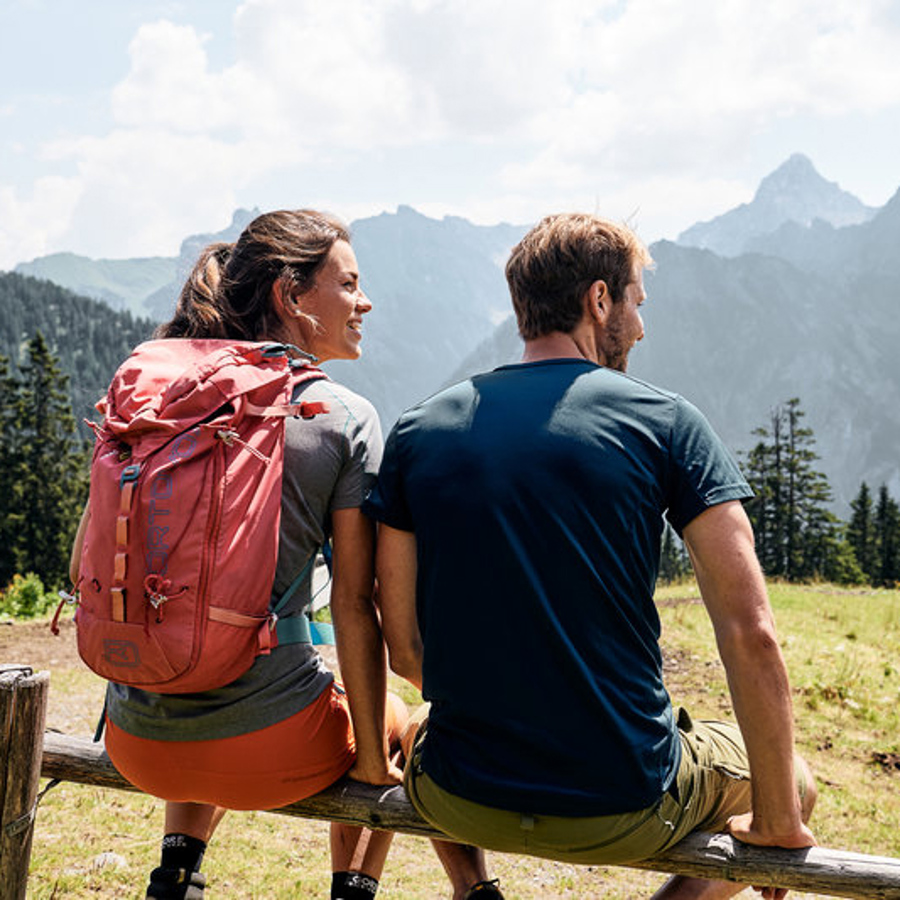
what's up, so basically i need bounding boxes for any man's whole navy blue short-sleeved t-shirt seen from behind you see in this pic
[364,359,751,816]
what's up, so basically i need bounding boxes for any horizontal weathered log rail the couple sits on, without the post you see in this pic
[42,733,900,900]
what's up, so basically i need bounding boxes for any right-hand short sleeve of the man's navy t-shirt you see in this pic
[666,397,753,534]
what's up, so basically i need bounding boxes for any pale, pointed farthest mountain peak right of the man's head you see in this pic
[677,153,876,256]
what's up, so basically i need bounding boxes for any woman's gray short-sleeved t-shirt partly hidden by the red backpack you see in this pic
[107,380,382,741]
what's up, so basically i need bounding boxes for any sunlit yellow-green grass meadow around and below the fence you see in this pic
[7,583,900,900]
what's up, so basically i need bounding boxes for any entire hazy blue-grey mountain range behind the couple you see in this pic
[7,154,900,506]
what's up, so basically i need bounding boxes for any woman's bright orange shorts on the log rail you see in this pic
[106,684,358,809]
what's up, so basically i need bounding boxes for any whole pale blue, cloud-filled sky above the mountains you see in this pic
[0,0,900,269]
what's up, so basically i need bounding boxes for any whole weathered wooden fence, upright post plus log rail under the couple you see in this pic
[0,666,900,900]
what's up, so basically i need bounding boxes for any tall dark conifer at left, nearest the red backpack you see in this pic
[7,332,87,586]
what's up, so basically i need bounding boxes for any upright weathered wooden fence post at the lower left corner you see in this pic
[0,664,50,900]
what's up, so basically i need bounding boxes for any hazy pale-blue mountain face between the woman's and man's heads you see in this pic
[326,206,526,427]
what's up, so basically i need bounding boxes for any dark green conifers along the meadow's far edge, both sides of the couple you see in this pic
[0,332,900,591]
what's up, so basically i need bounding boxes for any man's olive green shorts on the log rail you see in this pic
[404,709,806,865]
